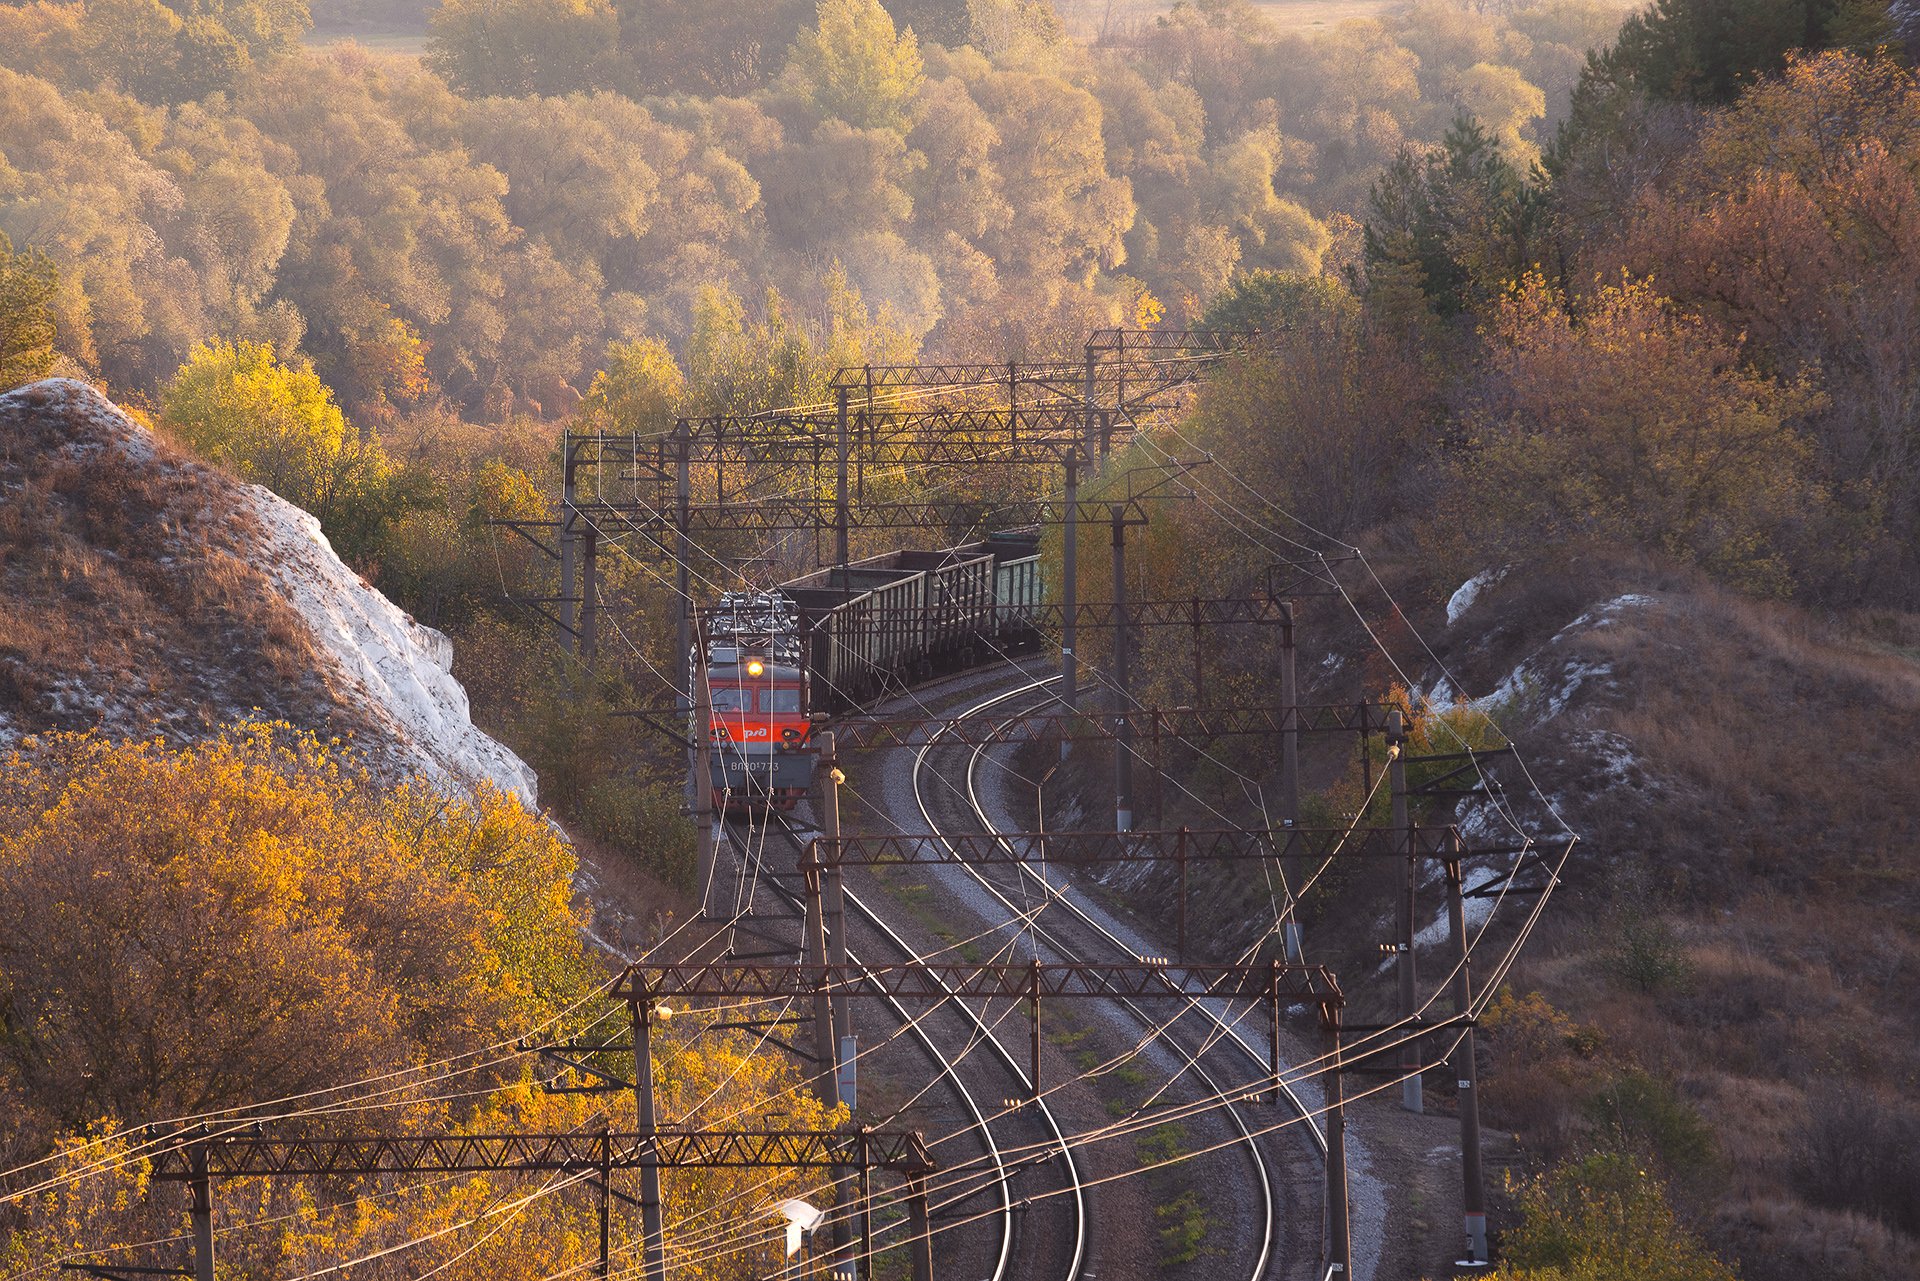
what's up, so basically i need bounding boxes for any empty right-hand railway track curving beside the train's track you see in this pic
[912,678,1325,1281]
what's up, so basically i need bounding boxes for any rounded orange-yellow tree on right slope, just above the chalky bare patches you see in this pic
[1438,273,1822,593]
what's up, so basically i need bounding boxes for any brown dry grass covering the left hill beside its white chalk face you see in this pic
[0,382,359,739]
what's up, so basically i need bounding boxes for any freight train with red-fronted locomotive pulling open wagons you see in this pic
[701,530,1044,809]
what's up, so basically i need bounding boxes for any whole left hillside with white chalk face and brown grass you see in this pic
[0,378,536,805]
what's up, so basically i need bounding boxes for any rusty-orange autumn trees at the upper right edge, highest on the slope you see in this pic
[1601,52,1920,576]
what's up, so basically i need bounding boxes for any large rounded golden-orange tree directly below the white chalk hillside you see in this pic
[0,724,589,1127]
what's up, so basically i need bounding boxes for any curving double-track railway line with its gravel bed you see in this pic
[714,668,1325,1281]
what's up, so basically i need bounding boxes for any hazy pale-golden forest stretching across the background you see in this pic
[0,0,1620,410]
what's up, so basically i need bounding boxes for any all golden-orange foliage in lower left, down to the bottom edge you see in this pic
[0,724,845,1281]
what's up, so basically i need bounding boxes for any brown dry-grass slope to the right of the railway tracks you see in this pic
[1444,567,1920,1281]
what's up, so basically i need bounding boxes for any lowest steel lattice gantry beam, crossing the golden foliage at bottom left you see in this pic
[152,1129,935,1183]
